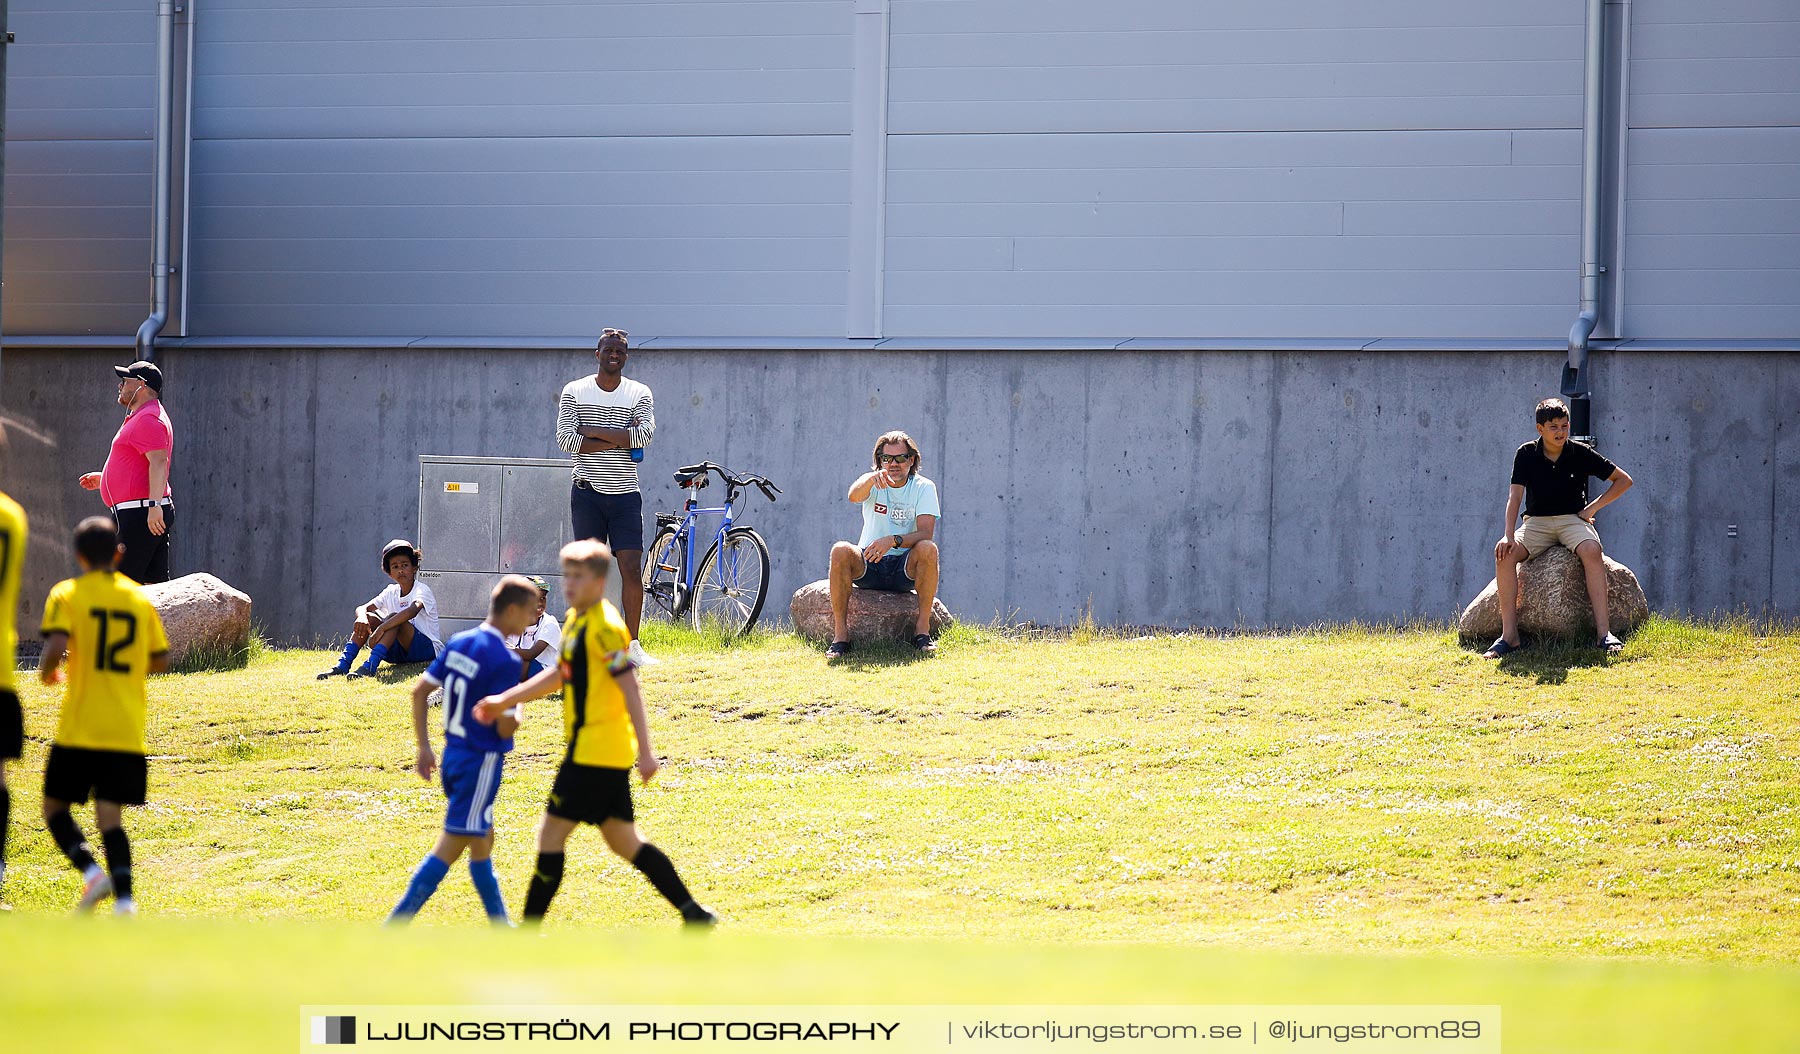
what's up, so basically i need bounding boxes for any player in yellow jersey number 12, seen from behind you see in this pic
[38,516,169,916]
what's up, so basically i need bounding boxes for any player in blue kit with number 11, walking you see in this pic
[387,574,542,926]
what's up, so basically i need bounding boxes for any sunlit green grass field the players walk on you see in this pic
[0,621,1800,1050]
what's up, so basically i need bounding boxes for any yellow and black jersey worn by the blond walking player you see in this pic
[562,601,637,768]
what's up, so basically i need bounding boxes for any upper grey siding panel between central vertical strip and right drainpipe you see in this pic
[889,0,1582,133]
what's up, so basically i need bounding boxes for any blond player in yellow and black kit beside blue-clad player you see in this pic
[475,538,718,926]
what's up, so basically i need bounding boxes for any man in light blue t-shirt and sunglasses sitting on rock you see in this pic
[824,432,938,658]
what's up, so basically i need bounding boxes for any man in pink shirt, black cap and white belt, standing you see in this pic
[81,362,175,585]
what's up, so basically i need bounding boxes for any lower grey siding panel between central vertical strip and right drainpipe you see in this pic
[887,131,1580,338]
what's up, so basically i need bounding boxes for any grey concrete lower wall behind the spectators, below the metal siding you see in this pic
[0,349,1800,640]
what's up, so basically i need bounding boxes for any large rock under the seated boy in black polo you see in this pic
[1456,545,1651,642]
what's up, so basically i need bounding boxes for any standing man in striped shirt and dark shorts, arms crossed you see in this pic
[556,329,659,665]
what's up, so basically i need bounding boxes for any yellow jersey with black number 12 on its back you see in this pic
[43,570,169,754]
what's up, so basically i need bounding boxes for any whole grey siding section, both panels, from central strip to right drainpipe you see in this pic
[886,0,1582,338]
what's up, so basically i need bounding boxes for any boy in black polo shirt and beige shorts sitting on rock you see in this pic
[1483,399,1631,658]
